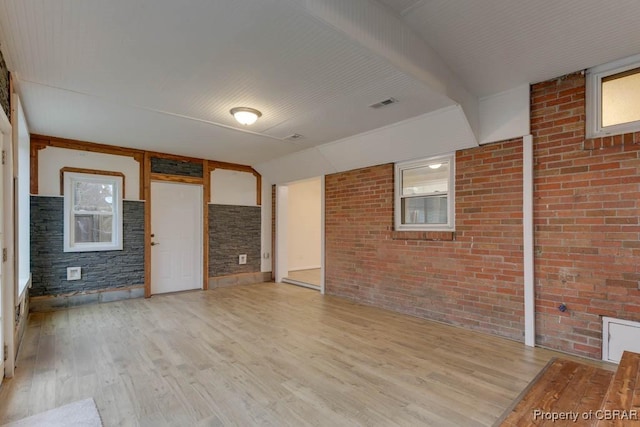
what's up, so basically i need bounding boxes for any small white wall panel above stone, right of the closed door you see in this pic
[210,169,257,206]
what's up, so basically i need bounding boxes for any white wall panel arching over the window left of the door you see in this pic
[38,147,141,200]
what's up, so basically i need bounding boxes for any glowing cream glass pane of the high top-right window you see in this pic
[602,68,640,127]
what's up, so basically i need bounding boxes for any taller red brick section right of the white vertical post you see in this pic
[531,74,640,358]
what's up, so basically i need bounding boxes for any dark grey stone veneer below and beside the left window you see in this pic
[30,196,145,296]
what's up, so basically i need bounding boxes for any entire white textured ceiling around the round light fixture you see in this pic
[0,0,640,165]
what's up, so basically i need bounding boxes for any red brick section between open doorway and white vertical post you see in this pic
[325,140,523,340]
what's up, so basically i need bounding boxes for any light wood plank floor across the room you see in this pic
[0,284,608,426]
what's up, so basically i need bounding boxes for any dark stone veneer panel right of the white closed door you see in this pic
[209,204,262,277]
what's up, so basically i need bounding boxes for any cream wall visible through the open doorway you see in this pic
[287,178,322,271]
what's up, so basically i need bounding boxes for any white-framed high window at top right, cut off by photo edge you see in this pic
[586,55,640,138]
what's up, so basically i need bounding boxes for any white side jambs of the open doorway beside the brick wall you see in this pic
[274,175,325,295]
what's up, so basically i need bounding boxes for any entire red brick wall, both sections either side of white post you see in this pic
[326,74,640,358]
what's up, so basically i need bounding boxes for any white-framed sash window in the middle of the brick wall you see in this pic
[395,154,455,231]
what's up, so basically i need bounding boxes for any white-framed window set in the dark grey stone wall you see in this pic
[63,172,123,252]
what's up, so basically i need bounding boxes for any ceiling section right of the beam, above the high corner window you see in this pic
[379,0,640,96]
